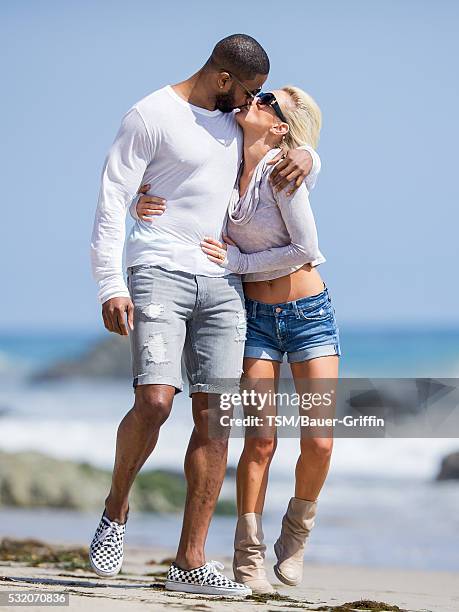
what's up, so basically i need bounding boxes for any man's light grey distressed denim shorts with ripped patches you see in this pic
[127,264,246,396]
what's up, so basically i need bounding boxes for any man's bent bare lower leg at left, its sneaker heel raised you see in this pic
[105,385,175,523]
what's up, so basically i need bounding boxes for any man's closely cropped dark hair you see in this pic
[207,34,269,80]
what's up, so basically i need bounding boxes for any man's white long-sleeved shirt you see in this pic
[91,85,320,303]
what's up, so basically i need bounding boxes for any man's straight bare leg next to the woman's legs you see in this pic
[176,393,228,569]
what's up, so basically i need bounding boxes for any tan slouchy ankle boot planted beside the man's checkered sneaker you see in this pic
[233,512,275,593]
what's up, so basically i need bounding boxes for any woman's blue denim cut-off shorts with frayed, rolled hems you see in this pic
[244,283,341,363]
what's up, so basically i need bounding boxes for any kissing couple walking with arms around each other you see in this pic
[90,34,341,597]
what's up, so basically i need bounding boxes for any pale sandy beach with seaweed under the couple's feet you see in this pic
[0,547,459,612]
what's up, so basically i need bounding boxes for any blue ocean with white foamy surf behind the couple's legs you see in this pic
[0,326,459,570]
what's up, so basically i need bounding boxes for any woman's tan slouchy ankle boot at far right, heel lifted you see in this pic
[274,497,317,586]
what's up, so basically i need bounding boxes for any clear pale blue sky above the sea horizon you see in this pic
[0,0,459,330]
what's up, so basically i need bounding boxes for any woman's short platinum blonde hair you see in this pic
[282,85,322,149]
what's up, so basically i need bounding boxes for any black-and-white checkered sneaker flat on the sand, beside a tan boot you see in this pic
[166,561,252,597]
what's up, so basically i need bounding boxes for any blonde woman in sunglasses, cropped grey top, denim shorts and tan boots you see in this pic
[133,87,341,593]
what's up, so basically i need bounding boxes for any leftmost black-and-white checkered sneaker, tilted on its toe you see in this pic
[89,510,127,578]
